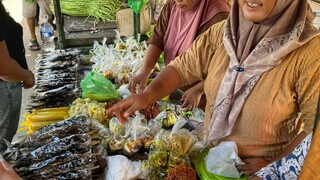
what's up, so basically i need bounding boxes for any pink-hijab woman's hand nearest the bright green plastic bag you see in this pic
[128,73,148,94]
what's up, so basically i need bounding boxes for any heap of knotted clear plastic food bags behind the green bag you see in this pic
[90,34,147,87]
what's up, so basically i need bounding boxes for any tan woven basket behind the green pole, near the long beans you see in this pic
[116,6,151,36]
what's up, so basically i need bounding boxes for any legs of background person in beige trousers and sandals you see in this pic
[22,0,53,51]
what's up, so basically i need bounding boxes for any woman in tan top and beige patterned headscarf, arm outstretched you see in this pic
[106,0,320,176]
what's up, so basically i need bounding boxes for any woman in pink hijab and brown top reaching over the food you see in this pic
[129,0,230,110]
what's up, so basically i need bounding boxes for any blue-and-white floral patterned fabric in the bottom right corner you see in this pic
[253,133,312,180]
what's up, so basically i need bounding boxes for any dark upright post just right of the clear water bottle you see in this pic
[53,0,66,49]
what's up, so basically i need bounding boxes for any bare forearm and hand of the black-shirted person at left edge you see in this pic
[0,41,35,88]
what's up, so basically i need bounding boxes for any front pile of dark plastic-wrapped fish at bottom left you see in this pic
[4,115,110,180]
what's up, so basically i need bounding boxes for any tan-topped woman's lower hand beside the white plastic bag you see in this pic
[237,158,270,176]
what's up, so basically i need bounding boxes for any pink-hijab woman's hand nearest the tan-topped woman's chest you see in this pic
[181,83,203,111]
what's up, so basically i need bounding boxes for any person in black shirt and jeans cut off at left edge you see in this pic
[0,0,35,152]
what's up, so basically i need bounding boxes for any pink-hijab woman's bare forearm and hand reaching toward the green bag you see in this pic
[129,44,162,93]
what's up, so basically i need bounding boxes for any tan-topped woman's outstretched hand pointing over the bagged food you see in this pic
[106,93,149,124]
